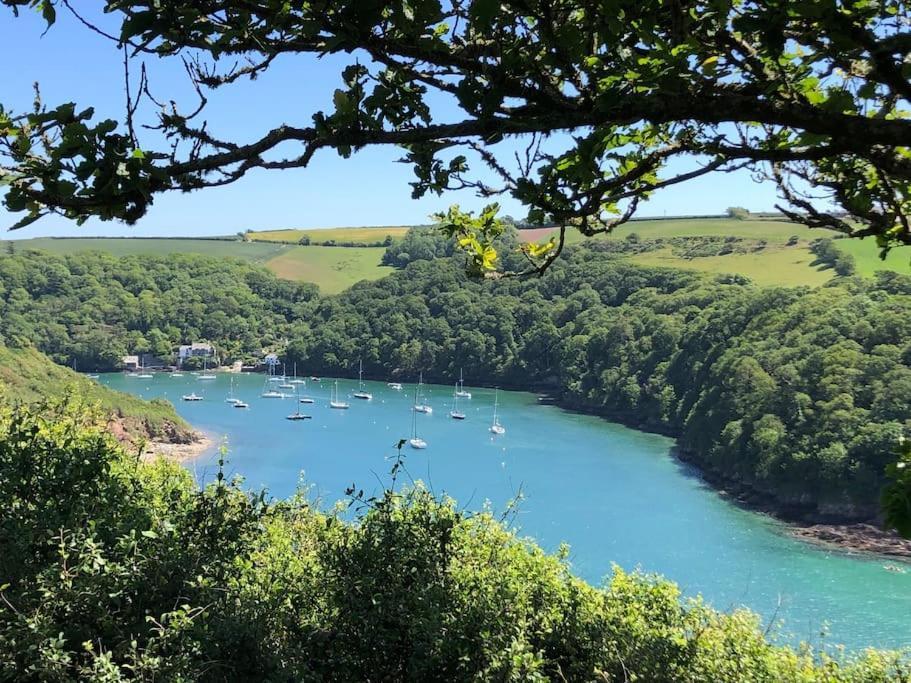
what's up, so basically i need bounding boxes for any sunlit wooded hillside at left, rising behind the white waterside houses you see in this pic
[0,252,316,371]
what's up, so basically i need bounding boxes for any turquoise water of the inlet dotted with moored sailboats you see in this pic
[100,374,911,649]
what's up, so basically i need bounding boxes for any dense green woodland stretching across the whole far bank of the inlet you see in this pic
[0,240,911,520]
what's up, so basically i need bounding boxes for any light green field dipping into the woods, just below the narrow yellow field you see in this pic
[266,246,392,294]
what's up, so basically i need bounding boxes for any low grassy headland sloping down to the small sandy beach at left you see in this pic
[0,345,193,442]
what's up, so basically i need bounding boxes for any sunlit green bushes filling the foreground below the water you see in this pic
[0,409,908,681]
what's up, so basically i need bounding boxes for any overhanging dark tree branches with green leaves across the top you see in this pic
[0,0,911,271]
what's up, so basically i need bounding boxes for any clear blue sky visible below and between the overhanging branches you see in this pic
[0,3,775,238]
